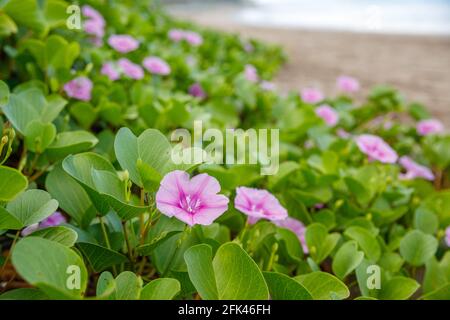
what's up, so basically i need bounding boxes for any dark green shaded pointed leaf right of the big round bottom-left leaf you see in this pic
[77,242,128,272]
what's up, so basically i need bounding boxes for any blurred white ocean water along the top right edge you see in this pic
[165,0,450,36]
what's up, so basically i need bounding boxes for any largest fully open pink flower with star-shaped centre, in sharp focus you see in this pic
[156,170,229,226]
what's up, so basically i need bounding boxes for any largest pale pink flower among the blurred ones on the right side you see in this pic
[356,134,398,163]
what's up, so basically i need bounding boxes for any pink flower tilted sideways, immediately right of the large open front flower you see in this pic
[234,187,287,221]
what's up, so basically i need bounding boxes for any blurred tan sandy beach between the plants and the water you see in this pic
[170,6,450,127]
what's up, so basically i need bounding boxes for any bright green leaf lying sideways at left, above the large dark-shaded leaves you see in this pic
[46,131,98,159]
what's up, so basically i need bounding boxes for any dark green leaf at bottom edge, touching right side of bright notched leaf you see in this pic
[263,272,313,300]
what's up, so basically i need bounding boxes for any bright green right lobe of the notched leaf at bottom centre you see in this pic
[213,242,269,300]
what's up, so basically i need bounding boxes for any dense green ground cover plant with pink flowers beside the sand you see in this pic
[0,0,450,300]
